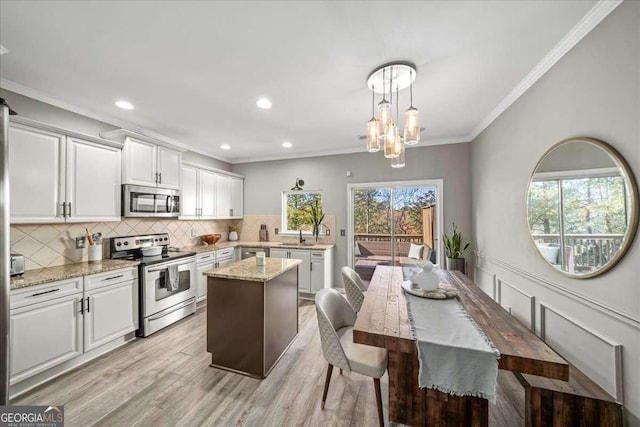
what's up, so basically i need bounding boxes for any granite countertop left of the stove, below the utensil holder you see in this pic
[9,259,140,290]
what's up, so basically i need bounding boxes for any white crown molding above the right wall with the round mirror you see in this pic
[469,0,623,141]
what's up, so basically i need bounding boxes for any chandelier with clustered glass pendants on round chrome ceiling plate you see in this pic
[367,61,420,168]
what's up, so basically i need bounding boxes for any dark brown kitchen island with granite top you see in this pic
[203,258,301,378]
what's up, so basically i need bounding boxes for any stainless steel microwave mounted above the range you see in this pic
[122,184,180,218]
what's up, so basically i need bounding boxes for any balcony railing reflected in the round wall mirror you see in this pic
[533,234,624,272]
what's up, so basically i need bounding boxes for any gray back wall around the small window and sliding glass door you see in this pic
[232,144,471,286]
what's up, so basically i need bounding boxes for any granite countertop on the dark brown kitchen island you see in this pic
[202,258,302,282]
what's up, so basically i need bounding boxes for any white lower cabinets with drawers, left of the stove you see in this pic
[10,268,138,385]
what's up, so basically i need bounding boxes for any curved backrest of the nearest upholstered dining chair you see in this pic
[315,288,356,371]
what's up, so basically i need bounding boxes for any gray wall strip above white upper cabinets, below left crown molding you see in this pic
[0,89,231,170]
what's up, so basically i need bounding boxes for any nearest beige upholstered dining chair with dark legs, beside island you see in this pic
[315,288,387,426]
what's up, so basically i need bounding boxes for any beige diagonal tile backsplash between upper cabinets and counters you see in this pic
[10,215,336,270]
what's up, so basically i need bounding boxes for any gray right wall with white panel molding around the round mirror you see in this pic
[471,2,640,426]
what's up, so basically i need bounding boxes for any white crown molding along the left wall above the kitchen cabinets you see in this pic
[0,78,231,163]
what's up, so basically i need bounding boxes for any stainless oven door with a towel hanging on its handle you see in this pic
[142,257,197,317]
